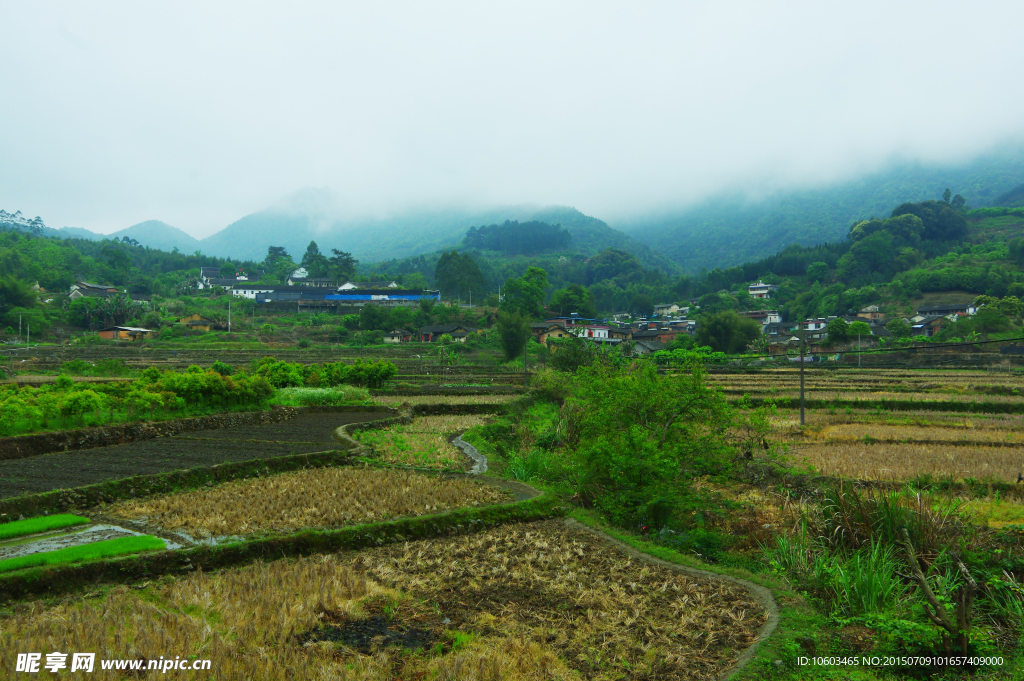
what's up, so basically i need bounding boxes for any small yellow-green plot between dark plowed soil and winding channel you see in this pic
[356,415,484,470]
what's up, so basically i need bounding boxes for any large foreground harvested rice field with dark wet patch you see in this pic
[0,520,767,681]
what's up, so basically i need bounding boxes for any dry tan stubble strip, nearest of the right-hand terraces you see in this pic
[793,442,1024,482]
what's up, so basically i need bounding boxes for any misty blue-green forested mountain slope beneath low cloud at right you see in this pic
[616,146,1024,273]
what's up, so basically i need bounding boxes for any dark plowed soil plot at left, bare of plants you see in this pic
[0,413,387,499]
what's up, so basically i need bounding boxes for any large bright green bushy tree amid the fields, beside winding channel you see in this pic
[562,361,749,528]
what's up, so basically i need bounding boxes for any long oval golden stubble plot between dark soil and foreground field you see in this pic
[108,467,510,537]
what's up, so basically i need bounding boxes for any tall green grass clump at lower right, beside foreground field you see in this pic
[762,487,991,654]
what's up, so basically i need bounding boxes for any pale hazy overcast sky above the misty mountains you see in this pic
[0,0,1024,238]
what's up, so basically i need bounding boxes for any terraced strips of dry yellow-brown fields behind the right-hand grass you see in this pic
[713,369,1024,482]
